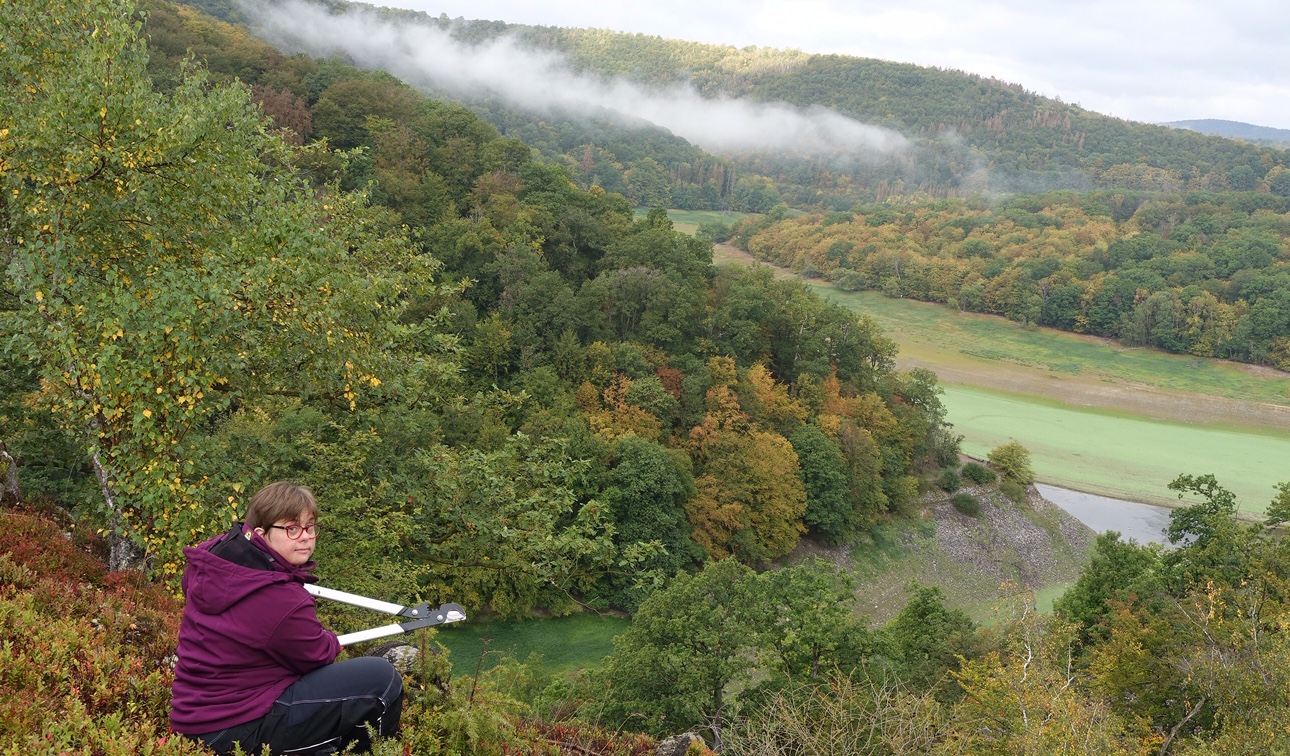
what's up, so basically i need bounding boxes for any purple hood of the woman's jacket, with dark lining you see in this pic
[183,522,317,614]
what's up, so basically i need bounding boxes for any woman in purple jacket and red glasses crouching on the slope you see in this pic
[170,481,402,753]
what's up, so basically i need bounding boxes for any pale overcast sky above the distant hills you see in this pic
[374,0,1290,129]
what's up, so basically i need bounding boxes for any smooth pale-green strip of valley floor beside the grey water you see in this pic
[942,386,1290,511]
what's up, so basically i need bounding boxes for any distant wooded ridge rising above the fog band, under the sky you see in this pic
[477,19,1290,202]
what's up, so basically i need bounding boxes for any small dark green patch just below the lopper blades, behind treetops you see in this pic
[435,614,631,675]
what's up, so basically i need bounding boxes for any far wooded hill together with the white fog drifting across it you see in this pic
[174,3,1290,213]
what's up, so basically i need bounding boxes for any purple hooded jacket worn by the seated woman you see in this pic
[170,524,341,735]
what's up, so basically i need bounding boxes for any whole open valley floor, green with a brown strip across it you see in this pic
[716,246,1290,512]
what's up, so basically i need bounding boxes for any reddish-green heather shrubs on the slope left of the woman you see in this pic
[0,513,193,756]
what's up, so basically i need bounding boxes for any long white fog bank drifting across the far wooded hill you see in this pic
[245,1,907,156]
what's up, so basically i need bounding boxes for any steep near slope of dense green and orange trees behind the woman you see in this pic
[3,1,955,615]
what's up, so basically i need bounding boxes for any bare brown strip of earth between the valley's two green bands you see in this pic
[713,244,1290,432]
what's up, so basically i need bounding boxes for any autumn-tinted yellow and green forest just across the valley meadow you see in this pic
[734,190,1290,370]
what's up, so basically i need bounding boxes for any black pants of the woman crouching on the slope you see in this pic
[199,657,402,756]
